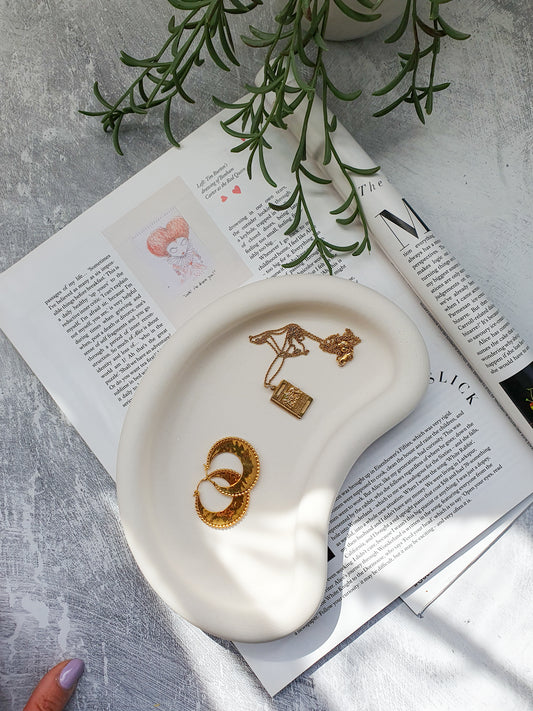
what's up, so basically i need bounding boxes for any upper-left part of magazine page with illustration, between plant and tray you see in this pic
[0,112,347,478]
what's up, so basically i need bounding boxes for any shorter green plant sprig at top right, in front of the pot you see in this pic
[374,0,470,123]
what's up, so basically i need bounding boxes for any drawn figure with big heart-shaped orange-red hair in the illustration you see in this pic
[146,217,205,284]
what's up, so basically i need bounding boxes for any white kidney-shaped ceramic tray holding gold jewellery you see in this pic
[117,276,429,642]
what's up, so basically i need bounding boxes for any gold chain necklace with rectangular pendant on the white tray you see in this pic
[249,323,361,419]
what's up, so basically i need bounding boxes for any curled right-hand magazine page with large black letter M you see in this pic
[282,94,533,446]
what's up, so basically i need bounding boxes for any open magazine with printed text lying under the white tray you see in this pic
[0,104,533,694]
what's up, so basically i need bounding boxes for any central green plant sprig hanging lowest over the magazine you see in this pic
[215,0,379,273]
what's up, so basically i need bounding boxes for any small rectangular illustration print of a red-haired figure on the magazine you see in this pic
[103,181,251,327]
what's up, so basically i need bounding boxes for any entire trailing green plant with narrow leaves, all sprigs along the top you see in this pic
[82,0,469,273]
